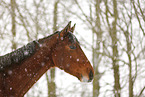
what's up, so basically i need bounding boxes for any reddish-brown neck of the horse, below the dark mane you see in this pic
[0,34,58,97]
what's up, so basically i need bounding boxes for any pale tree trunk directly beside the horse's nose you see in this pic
[92,0,102,97]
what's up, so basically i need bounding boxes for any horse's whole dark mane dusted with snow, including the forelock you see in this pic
[0,31,78,71]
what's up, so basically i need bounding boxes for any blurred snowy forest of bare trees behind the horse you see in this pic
[0,0,145,97]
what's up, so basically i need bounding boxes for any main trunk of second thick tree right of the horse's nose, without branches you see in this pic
[110,0,121,97]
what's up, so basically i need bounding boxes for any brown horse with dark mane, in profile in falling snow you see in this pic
[0,22,94,97]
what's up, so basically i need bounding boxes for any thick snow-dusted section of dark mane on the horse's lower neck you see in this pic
[0,41,38,70]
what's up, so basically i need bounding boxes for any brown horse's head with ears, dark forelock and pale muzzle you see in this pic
[52,22,94,82]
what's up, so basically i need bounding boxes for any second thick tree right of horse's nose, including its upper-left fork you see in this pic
[105,0,121,97]
